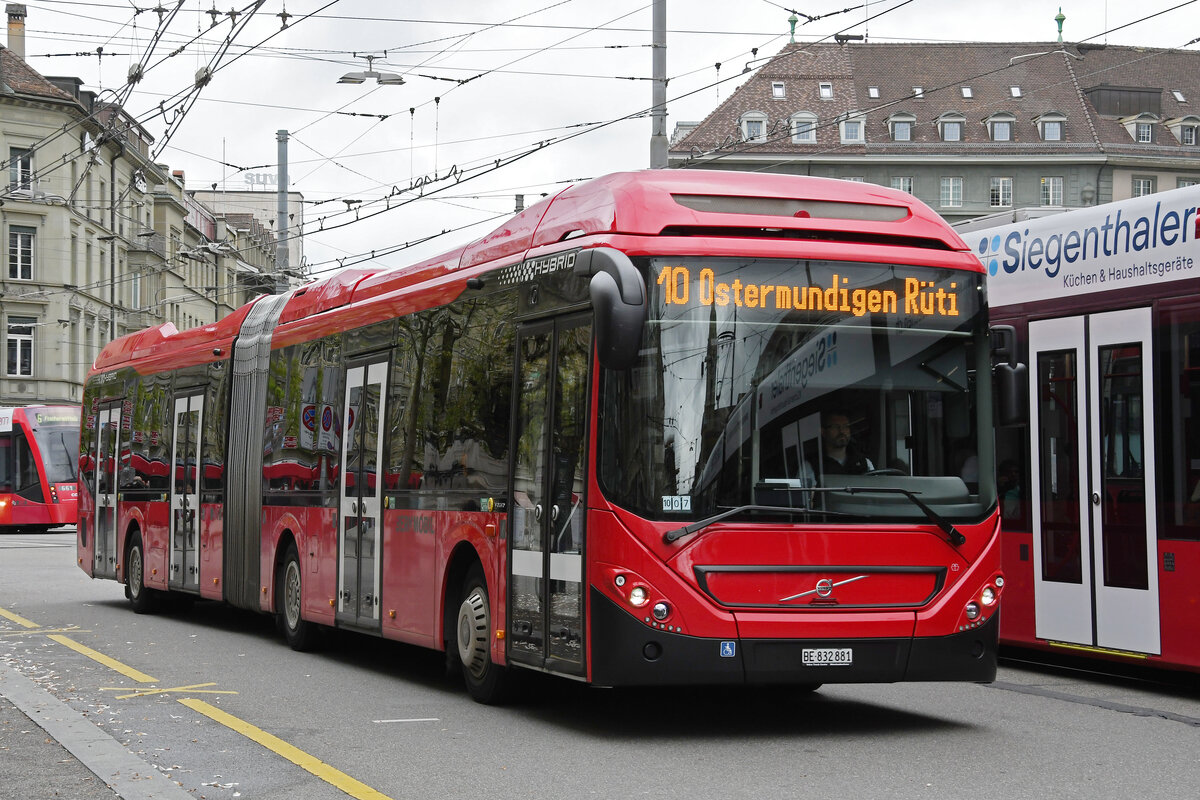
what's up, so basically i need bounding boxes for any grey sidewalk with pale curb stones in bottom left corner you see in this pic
[0,663,193,800]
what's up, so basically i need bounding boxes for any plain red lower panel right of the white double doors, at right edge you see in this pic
[1158,539,1200,669]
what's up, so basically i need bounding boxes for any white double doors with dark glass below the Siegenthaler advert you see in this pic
[1030,308,1160,654]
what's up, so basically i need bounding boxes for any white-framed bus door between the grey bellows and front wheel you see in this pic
[337,361,388,628]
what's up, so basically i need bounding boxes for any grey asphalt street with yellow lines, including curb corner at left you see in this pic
[0,531,1200,800]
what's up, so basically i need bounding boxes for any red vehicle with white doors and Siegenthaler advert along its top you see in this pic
[962,186,1200,670]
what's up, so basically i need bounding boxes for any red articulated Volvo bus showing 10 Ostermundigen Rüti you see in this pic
[79,170,1003,702]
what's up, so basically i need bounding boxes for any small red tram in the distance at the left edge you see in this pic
[0,405,79,533]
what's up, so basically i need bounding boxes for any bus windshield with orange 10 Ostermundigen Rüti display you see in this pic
[599,258,996,524]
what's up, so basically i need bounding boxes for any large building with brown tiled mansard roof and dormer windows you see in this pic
[670,42,1200,222]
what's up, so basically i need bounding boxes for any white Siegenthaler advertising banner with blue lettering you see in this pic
[964,187,1200,307]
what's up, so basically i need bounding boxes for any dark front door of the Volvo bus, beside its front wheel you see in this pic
[506,317,592,675]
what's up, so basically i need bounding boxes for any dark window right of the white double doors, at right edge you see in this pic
[1157,307,1200,540]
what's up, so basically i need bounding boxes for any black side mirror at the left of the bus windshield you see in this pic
[575,247,649,369]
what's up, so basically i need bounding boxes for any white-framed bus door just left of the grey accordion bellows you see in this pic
[168,395,204,589]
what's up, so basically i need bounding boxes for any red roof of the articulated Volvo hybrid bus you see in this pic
[92,169,968,372]
